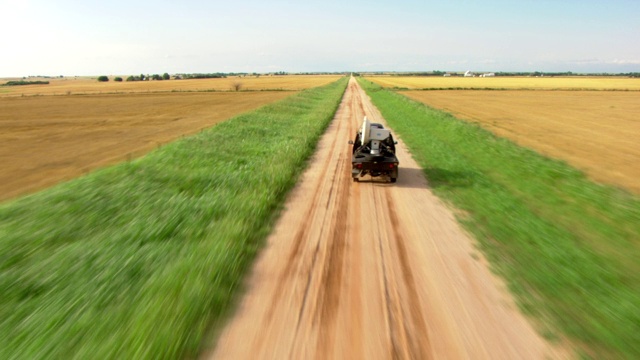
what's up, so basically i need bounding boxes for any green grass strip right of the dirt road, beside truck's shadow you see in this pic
[360,79,640,358]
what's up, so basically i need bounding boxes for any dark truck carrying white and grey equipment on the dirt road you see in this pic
[349,116,399,183]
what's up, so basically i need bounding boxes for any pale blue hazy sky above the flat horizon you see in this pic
[0,0,640,77]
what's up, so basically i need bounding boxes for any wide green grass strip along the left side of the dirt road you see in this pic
[0,78,347,359]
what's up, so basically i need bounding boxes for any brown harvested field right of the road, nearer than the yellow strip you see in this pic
[401,89,640,193]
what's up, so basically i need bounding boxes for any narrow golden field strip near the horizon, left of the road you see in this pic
[0,75,340,97]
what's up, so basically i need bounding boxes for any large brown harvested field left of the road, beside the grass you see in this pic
[0,91,291,200]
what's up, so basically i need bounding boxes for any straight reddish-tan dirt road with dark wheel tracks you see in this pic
[205,79,559,359]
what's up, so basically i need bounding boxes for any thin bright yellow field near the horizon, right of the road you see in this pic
[367,76,640,91]
